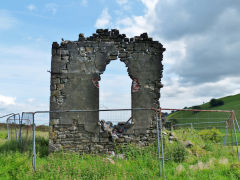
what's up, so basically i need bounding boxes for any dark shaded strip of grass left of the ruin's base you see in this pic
[0,137,48,157]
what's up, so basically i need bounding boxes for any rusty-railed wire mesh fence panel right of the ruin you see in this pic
[161,109,240,168]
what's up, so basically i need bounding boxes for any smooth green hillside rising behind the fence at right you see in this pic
[167,94,240,128]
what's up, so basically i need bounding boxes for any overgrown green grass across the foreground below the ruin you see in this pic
[0,129,240,180]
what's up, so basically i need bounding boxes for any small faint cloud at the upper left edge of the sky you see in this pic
[0,10,17,30]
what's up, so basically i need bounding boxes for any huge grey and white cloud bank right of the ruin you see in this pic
[98,0,240,108]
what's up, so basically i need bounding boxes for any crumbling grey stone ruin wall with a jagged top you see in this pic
[49,29,165,153]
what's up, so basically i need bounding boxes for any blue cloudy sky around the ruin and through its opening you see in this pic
[0,0,240,122]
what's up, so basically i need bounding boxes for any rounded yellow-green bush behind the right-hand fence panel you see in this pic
[200,128,223,143]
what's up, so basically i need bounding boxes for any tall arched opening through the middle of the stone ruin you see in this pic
[99,59,132,124]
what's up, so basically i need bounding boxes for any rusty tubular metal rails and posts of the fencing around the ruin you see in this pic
[0,108,240,178]
